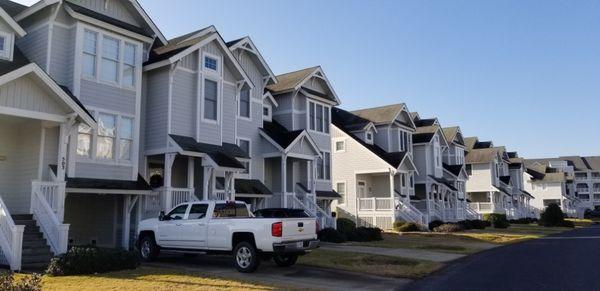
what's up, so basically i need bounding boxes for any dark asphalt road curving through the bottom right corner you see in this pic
[404,226,600,291]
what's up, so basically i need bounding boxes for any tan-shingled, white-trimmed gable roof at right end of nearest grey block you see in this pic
[267,66,341,105]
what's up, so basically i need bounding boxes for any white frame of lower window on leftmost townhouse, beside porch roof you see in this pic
[75,106,138,167]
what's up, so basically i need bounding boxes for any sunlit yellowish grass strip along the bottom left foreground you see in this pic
[19,266,281,291]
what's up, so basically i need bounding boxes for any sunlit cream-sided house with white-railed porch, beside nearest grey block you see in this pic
[331,104,427,229]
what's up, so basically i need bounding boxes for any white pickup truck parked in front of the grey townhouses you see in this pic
[136,201,319,273]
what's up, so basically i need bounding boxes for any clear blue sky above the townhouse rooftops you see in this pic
[15,0,600,157]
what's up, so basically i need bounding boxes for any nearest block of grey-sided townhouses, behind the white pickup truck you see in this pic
[0,0,340,270]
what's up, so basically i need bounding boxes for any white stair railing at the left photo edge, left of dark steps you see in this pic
[0,198,25,271]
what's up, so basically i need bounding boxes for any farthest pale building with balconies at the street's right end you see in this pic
[525,156,600,217]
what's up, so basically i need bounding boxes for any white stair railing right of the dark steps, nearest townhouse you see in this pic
[31,181,69,255]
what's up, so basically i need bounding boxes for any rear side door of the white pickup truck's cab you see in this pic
[181,203,208,249]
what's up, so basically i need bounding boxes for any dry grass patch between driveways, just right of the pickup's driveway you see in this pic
[298,250,443,278]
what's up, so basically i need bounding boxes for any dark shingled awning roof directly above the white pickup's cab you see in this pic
[169,134,248,169]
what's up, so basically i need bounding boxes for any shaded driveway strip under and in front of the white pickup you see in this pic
[147,254,410,290]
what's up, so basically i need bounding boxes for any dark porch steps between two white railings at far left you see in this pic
[12,214,53,271]
